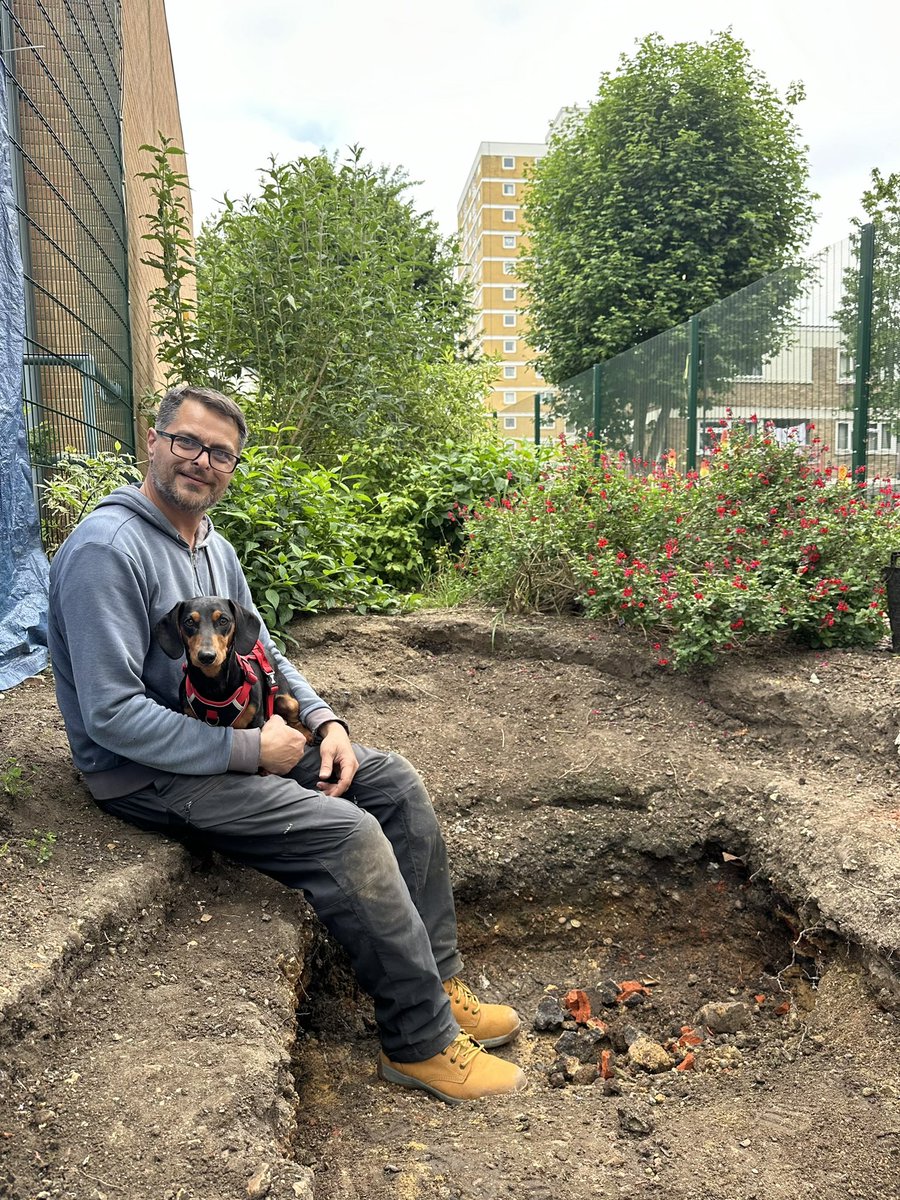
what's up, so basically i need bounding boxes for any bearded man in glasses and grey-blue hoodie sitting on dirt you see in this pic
[50,385,524,1102]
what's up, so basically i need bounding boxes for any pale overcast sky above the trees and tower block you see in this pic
[167,0,900,250]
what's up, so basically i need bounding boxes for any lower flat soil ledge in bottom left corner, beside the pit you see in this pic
[0,863,319,1200]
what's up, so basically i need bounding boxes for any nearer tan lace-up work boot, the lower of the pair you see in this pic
[378,1033,526,1104]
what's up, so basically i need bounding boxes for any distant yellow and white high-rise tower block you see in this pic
[457,142,563,440]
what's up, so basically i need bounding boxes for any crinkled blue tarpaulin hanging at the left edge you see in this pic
[0,64,48,691]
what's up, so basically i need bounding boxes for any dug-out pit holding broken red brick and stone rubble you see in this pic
[290,848,900,1200]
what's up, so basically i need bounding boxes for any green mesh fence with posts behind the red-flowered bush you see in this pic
[556,226,900,480]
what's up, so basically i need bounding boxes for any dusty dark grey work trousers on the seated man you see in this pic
[102,745,461,1062]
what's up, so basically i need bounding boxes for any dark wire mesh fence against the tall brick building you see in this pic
[0,0,134,540]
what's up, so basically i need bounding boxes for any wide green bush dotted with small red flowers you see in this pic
[460,427,900,666]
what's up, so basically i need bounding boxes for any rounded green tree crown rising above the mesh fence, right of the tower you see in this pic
[526,32,815,434]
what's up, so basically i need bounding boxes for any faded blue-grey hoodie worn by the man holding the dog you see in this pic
[49,485,343,800]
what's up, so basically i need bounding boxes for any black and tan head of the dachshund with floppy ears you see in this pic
[154,596,260,679]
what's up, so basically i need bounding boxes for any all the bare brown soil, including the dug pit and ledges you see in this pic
[0,611,900,1200]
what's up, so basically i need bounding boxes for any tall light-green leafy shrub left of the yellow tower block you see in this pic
[177,141,490,461]
